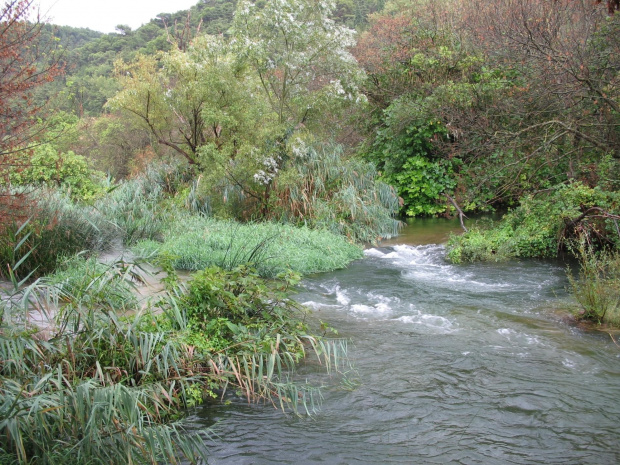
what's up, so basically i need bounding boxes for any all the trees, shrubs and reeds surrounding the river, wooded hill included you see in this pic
[0,0,620,464]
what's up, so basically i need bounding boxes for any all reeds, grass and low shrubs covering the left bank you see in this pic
[0,161,361,463]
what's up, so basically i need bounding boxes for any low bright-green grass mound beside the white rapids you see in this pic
[134,216,363,277]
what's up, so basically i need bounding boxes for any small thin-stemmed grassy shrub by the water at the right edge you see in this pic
[567,236,620,327]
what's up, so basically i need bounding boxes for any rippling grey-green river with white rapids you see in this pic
[192,221,620,464]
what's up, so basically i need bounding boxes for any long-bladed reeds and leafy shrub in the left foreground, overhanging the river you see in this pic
[0,252,346,465]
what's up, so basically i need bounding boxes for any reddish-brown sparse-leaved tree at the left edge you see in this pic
[0,0,62,222]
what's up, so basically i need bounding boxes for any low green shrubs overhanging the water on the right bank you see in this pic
[448,183,618,263]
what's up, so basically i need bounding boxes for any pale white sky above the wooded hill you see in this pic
[34,0,198,32]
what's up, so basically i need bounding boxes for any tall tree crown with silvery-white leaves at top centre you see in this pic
[233,0,364,128]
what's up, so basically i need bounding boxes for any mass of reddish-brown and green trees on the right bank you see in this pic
[355,0,620,213]
